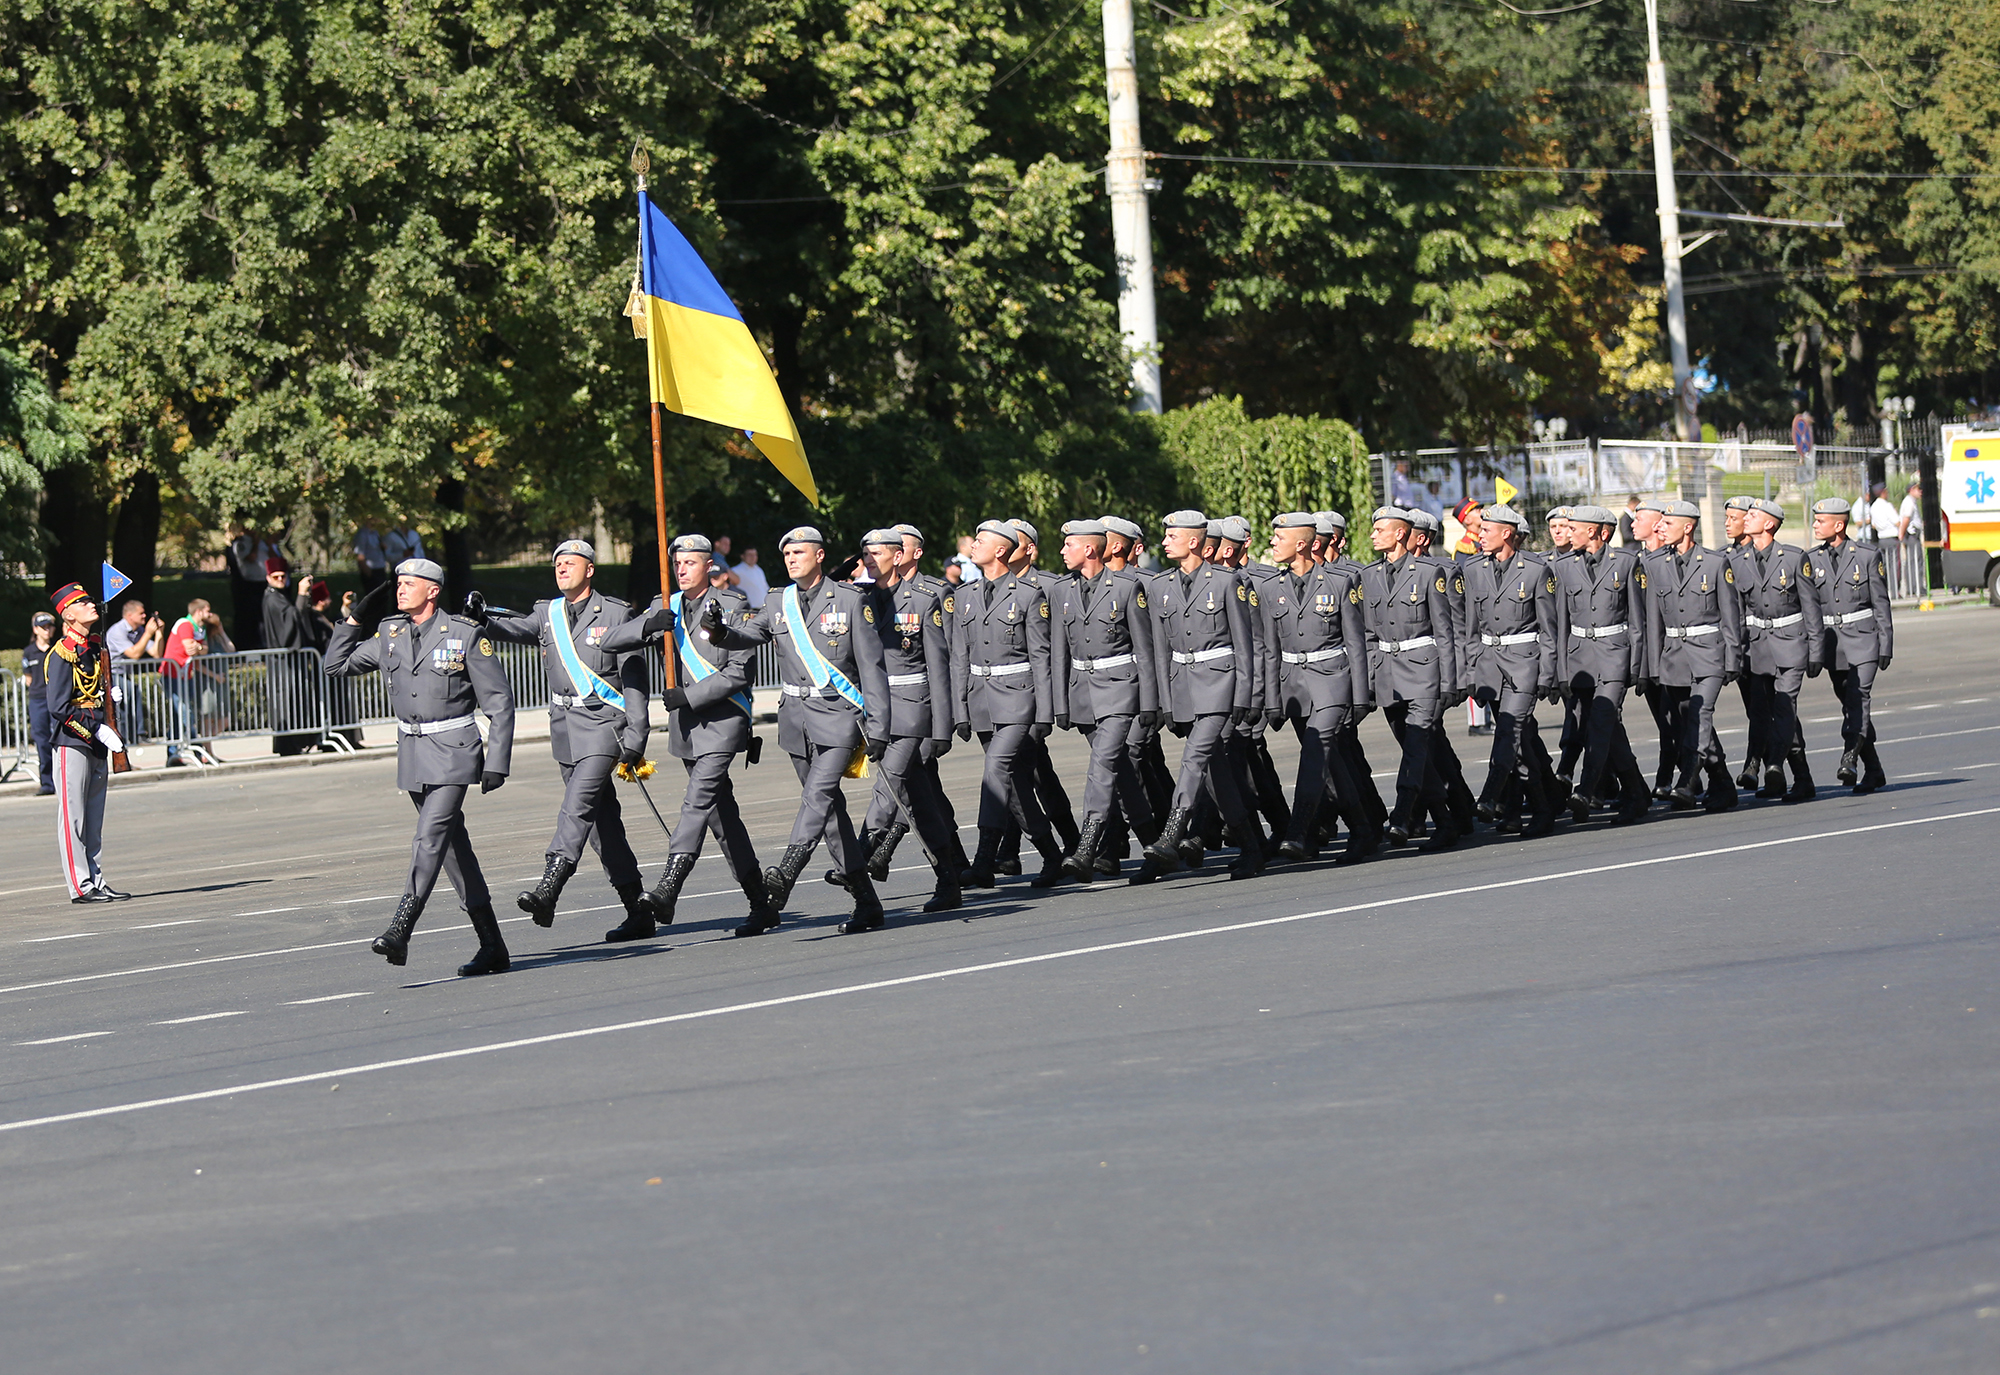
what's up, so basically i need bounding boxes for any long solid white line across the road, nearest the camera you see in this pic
[0,807,2000,1133]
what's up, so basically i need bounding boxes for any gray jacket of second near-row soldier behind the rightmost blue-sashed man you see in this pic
[946,574,1056,731]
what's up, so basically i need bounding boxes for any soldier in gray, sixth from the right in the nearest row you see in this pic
[1362,506,1458,849]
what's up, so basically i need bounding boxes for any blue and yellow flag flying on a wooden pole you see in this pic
[634,192,820,506]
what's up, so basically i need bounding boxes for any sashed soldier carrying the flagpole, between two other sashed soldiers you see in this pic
[604,536,778,941]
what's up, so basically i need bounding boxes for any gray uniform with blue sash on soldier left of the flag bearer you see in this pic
[486,592,648,887]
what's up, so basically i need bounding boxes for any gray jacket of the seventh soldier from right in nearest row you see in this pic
[1258,564,1370,715]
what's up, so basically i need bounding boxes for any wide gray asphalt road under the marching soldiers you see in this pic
[0,608,2000,1375]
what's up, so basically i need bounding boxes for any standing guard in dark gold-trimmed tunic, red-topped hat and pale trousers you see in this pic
[42,582,130,903]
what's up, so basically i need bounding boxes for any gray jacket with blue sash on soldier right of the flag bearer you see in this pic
[716,578,888,755]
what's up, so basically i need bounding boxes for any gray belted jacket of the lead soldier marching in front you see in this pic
[326,612,514,793]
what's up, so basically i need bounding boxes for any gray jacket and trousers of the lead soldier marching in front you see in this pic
[326,612,514,911]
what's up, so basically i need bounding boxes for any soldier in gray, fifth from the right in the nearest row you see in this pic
[1462,504,1568,839]
